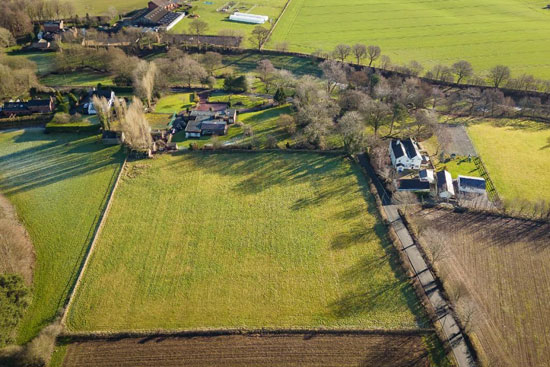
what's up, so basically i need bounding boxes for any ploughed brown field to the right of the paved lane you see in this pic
[408,209,550,367]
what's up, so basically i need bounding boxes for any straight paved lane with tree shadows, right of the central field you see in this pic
[358,154,475,367]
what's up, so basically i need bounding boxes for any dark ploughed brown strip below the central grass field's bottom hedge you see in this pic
[59,334,429,367]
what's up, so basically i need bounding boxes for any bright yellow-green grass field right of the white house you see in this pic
[468,121,550,201]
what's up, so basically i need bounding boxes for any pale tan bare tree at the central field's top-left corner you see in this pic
[120,97,153,151]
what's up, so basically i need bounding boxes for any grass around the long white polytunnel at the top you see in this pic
[170,0,286,40]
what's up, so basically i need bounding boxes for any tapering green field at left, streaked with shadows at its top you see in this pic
[0,129,123,343]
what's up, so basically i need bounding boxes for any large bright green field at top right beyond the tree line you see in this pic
[270,0,550,78]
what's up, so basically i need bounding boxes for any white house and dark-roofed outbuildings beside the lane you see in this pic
[389,138,486,200]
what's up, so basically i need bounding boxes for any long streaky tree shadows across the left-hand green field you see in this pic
[0,131,123,199]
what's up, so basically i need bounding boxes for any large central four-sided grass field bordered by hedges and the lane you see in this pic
[67,152,426,331]
